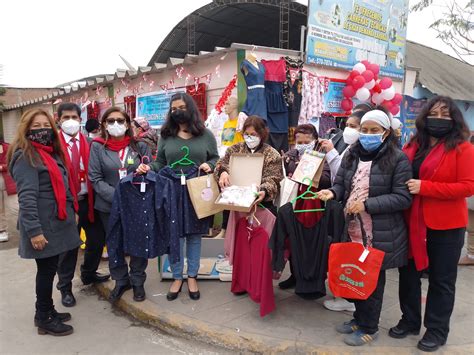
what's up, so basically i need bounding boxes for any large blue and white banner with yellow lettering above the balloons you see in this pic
[306,0,408,79]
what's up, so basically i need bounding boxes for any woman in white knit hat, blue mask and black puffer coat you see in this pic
[318,109,412,346]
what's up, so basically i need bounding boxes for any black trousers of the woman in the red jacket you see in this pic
[398,228,466,343]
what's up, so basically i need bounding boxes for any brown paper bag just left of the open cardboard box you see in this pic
[186,174,224,219]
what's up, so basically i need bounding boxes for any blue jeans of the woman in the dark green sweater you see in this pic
[171,234,201,280]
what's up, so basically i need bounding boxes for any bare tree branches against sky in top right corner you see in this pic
[411,0,474,62]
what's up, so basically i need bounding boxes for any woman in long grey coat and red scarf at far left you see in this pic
[7,109,81,336]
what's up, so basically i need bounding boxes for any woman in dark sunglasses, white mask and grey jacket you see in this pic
[89,107,151,302]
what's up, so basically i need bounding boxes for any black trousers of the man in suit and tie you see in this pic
[57,198,105,291]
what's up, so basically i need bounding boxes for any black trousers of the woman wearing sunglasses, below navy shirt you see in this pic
[99,212,148,286]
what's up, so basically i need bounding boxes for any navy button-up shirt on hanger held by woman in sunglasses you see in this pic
[107,171,179,266]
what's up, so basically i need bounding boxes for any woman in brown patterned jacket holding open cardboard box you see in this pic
[214,116,283,205]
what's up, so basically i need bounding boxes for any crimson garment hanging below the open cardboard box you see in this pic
[231,218,275,317]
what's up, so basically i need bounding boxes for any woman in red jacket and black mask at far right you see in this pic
[389,96,474,351]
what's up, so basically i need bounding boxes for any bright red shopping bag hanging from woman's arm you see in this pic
[328,216,385,300]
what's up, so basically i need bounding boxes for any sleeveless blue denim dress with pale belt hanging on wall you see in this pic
[240,59,267,120]
